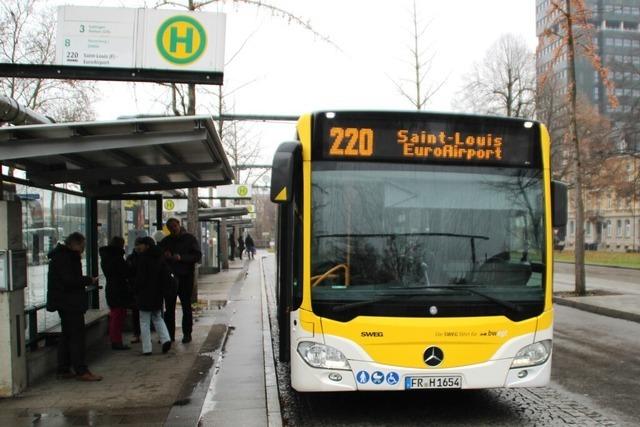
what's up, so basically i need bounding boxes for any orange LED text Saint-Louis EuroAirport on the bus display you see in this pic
[396,129,502,160]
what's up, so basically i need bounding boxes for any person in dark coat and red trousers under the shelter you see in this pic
[98,236,133,350]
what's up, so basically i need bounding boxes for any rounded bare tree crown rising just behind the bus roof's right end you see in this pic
[457,34,536,117]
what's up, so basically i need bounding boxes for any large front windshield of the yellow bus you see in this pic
[311,161,544,320]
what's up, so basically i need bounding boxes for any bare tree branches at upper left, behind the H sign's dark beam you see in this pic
[0,0,96,121]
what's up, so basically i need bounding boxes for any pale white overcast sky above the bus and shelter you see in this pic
[49,0,536,174]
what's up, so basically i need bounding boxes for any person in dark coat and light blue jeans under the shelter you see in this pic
[131,237,172,356]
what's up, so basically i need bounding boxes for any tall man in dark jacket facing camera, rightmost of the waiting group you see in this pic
[160,218,202,344]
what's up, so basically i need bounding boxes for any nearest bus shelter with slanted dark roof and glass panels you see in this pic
[0,116,233,396]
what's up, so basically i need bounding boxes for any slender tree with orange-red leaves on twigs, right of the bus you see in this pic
[540,0,617,295]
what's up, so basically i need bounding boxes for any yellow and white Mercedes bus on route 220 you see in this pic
[271,111,567,392]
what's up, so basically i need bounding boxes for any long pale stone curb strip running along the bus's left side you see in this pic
[260,257,282,427]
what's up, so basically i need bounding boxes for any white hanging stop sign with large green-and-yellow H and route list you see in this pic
[56,6,226,72]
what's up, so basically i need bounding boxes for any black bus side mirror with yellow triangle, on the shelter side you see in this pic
[271,142,302,203]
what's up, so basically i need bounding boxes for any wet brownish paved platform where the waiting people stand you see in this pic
[0,260,250,426]
